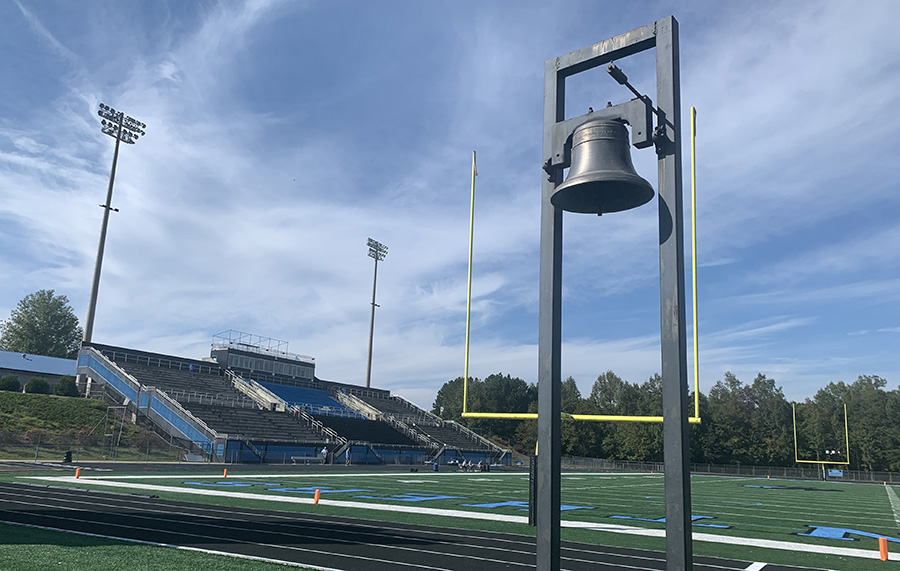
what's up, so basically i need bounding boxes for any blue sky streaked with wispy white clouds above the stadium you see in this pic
[0,0,900,407]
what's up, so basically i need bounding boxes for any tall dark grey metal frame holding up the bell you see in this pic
[536,16,692,571]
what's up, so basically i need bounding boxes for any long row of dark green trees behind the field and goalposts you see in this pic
[432,371,900,471]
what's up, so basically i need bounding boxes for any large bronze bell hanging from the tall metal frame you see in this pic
[550,119,653,215]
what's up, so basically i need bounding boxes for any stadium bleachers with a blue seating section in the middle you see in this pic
[92,345,510,461]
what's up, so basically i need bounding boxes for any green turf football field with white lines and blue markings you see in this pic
[16,468,900,570]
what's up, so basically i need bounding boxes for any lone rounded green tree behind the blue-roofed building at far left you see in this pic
[0,289,83,359]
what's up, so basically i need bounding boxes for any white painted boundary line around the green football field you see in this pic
[21,474,900,568]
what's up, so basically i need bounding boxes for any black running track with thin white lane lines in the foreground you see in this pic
[0,483,824,571]
